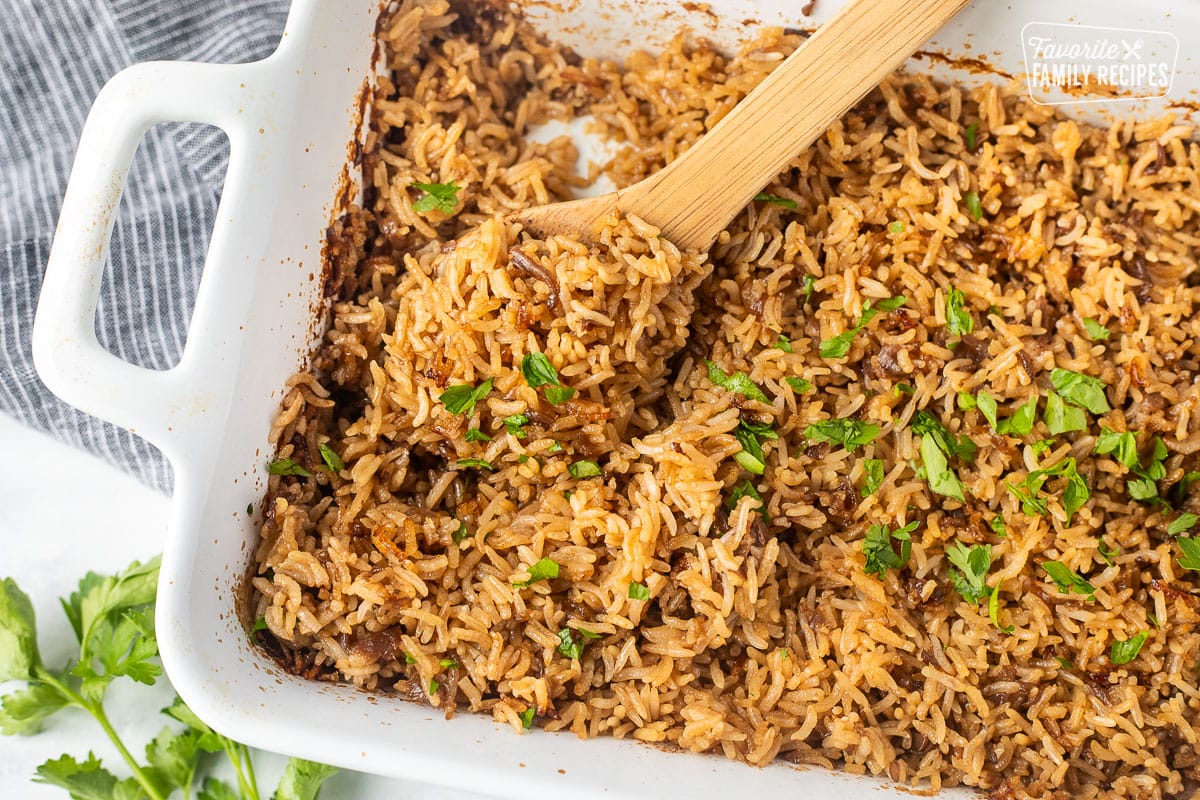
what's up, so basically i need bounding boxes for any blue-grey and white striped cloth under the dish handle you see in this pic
[0,0,288,491]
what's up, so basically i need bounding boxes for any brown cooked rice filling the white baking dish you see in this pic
[253,0,1200,798]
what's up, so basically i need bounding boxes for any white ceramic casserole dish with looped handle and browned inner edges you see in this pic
[34,0,1200,800]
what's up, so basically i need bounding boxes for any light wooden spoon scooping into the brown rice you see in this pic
[512,0,970,249]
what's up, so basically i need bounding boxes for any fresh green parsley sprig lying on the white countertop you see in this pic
[0,558,336,800]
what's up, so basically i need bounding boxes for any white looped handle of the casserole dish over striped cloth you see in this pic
[32,61,258,457]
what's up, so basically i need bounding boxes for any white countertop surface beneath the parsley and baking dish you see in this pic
[0,415,486,800]
